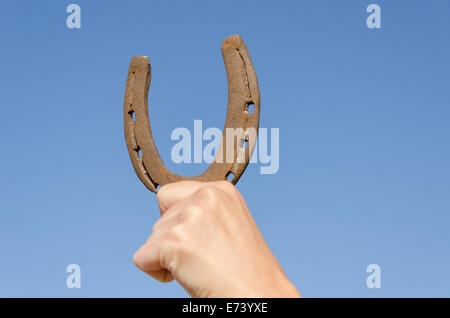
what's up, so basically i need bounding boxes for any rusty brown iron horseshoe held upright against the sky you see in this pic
[124,35,260,193]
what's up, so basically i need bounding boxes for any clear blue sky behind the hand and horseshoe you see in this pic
[0,0,450,297]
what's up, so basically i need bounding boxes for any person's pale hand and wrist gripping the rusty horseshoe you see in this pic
[134,181,301,298]
